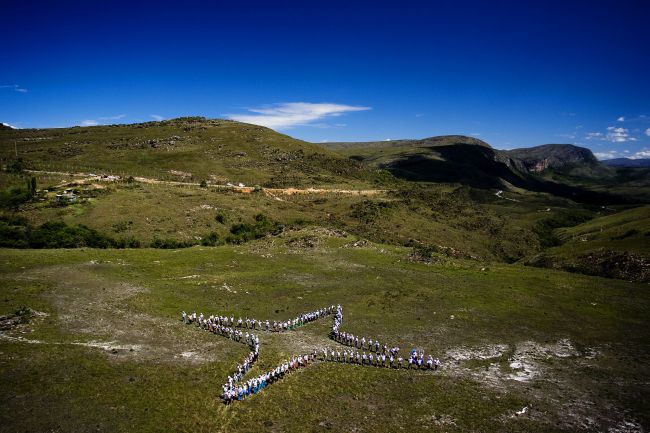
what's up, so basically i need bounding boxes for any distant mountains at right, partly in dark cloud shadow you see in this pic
[327,135,650,204]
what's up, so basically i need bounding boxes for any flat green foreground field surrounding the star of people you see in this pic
[0,233,650,432]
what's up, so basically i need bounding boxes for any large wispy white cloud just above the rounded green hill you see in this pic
[226,102,371,129]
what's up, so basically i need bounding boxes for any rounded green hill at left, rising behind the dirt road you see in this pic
[0,117,379,186]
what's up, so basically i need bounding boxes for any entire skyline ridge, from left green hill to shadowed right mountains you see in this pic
[0,117,650,205]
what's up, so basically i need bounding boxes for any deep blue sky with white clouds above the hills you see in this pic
[0,0,650,158]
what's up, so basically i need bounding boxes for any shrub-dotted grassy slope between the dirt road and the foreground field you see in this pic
[4,167,612,262]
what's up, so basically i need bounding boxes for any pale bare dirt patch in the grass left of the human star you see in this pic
[7,262,243,363]
